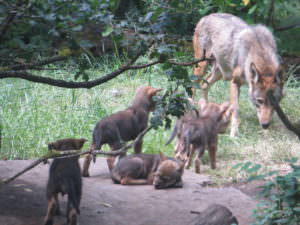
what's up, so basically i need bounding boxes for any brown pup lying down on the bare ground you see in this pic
[111,153,184,189]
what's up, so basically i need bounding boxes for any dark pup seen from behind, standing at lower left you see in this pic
[44,138,86,225]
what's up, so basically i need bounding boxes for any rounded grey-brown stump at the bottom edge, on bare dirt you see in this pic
[190,204,238,225]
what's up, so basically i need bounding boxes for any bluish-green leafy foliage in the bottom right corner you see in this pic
[236,158,300,225]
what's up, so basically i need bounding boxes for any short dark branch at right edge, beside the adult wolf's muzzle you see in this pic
[267,90,300,139]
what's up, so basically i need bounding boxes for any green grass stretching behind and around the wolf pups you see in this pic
[0,58,300,183]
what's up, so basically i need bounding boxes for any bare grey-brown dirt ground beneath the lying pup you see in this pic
[0,158,257,225]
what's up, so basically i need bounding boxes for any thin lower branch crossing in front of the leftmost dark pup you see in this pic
[0,126,152,185]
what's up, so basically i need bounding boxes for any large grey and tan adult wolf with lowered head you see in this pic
[193,13,284,136]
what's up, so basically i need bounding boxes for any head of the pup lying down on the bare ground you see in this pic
[153,153,184,189]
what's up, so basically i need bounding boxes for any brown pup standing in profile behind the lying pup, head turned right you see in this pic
[82,86,161,177]
